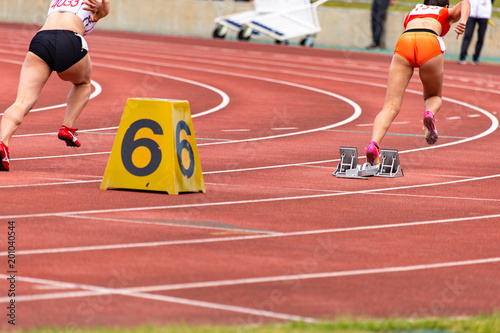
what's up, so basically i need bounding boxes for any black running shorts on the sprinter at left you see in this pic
[29,30,88,73]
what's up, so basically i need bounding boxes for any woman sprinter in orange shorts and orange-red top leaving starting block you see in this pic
[366,0,470,165]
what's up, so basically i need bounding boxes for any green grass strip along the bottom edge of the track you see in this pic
[9,313,500,333]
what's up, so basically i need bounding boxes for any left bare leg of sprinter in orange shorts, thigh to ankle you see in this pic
[372,54,413,146]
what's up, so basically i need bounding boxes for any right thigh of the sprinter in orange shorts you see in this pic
[419,54,444,100]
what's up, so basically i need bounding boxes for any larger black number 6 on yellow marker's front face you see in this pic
[122,119,163,177]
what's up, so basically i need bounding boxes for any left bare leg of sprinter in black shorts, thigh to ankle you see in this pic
[0,52,52,146]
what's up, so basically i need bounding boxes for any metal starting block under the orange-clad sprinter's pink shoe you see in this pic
[332,147,403,179]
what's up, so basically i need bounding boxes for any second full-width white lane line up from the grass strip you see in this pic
[0,214,500,257]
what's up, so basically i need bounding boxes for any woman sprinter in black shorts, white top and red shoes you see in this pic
[0,0,110,171]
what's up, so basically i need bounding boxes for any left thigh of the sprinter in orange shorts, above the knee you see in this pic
[385,54,413,109]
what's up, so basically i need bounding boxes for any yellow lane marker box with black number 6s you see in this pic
[101,98,205,194]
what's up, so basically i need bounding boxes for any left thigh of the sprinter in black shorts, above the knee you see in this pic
[17,52,52,108]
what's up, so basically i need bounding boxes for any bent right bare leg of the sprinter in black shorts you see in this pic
[58,54,92,128]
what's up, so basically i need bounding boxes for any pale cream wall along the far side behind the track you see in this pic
[0,0,500,58]
